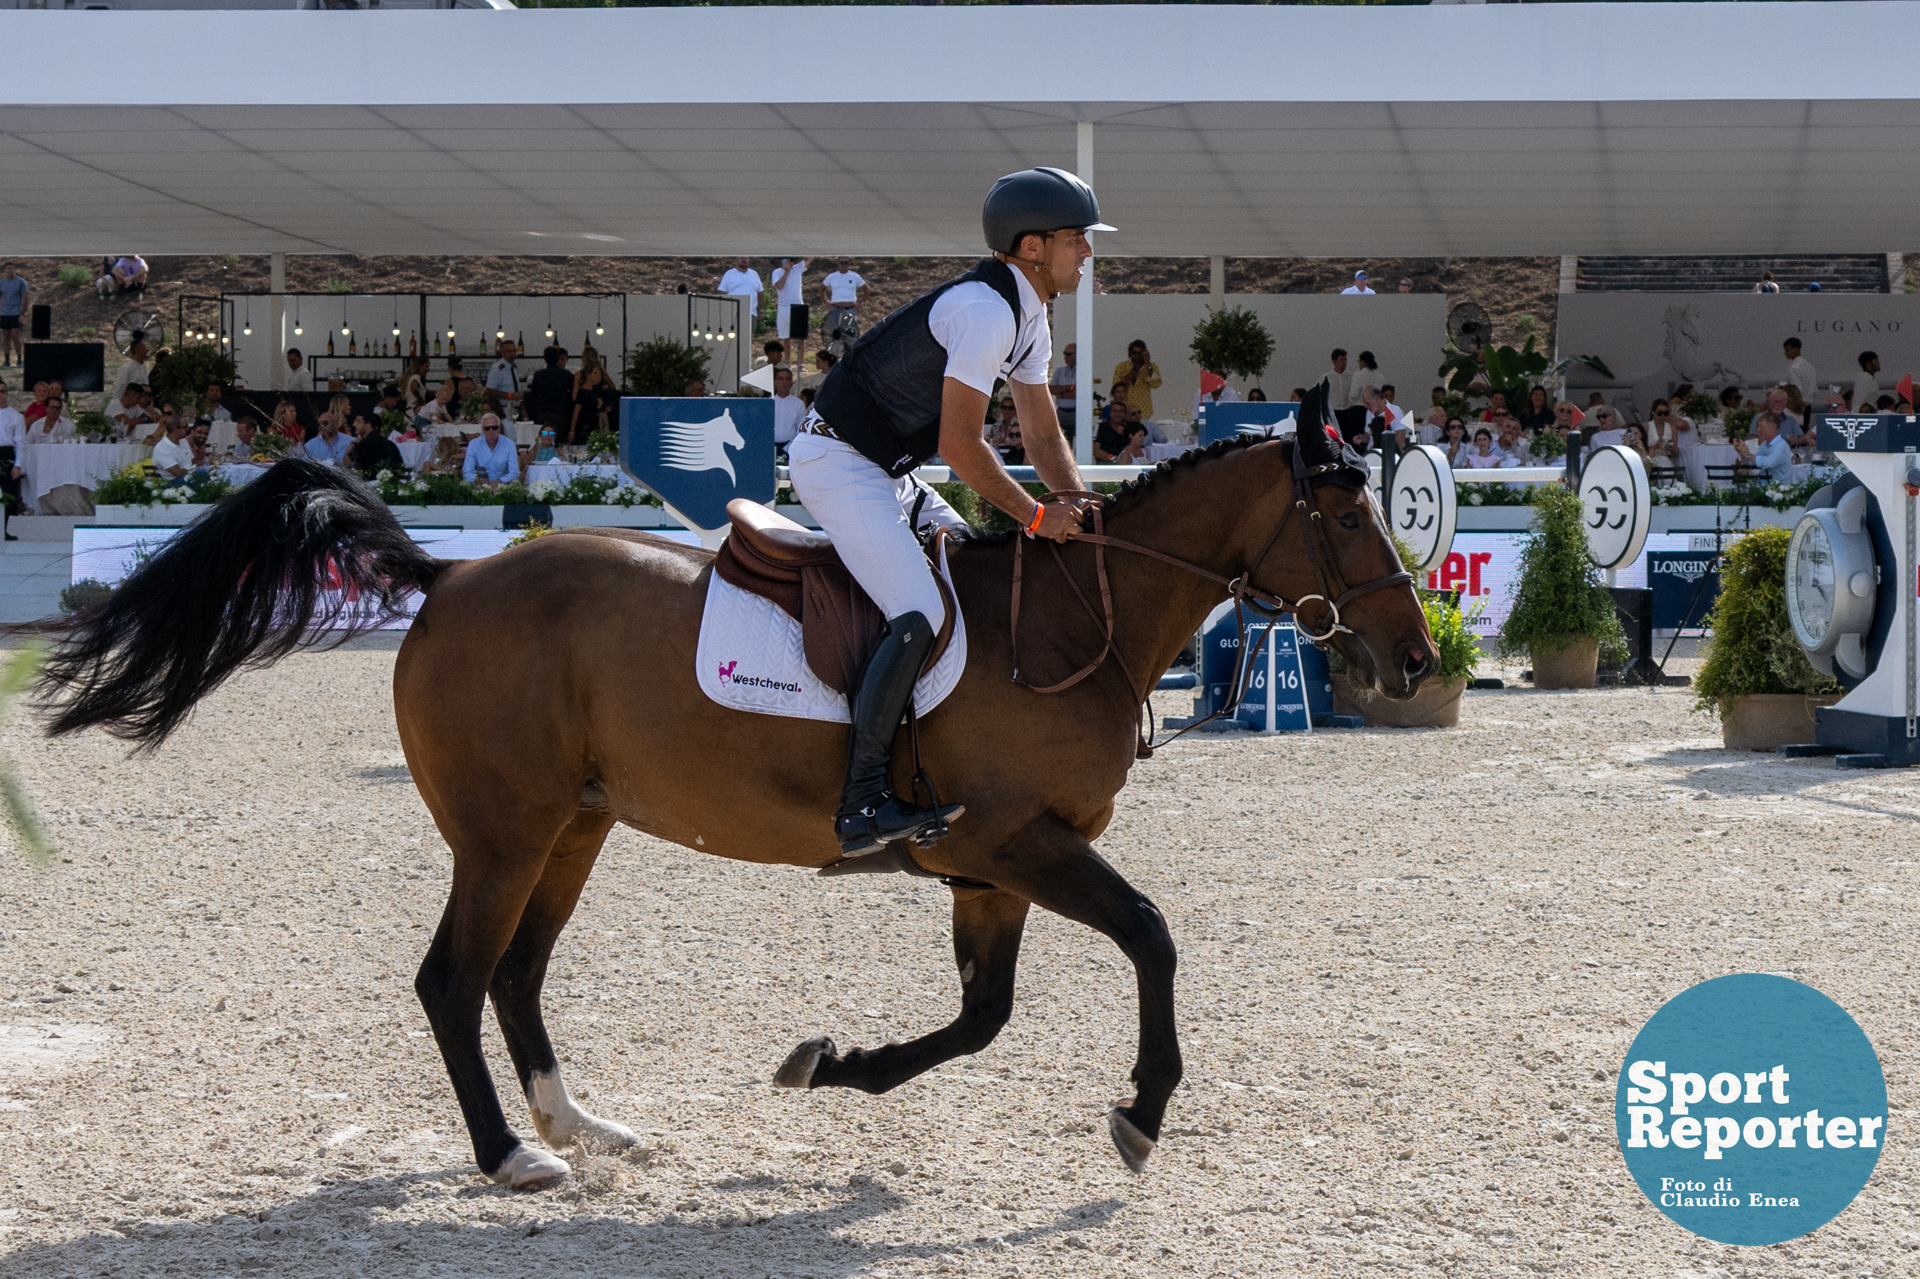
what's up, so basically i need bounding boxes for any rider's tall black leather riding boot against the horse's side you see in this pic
[833,613,964,857]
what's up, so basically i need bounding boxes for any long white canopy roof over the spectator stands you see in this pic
[0,0,1920,255]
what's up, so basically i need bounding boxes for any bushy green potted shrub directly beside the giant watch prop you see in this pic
[1693,528,1839,751]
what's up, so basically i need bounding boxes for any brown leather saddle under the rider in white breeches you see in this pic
[714,497,960,697]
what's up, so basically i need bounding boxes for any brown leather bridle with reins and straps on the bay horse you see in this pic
[1008,440,1413,759]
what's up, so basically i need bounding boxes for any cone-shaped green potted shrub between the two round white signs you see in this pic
[1500,484,1626,688]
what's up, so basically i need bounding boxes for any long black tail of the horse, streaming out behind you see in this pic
[42,459,447,751]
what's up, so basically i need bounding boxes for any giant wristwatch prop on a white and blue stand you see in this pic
[1786,413,1920,768]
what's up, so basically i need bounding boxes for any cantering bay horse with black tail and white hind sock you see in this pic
[40,432,1434,1189]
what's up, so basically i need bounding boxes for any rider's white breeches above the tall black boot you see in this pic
[787,434,968,626]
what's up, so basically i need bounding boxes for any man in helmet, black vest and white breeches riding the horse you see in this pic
[787,169,1112,857]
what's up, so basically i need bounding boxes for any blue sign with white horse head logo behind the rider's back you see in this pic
[620,398,774,528]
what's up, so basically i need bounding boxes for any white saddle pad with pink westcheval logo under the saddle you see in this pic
[693,533,966,724]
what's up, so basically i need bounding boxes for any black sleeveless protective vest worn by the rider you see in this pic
[814,257,1021,478]
